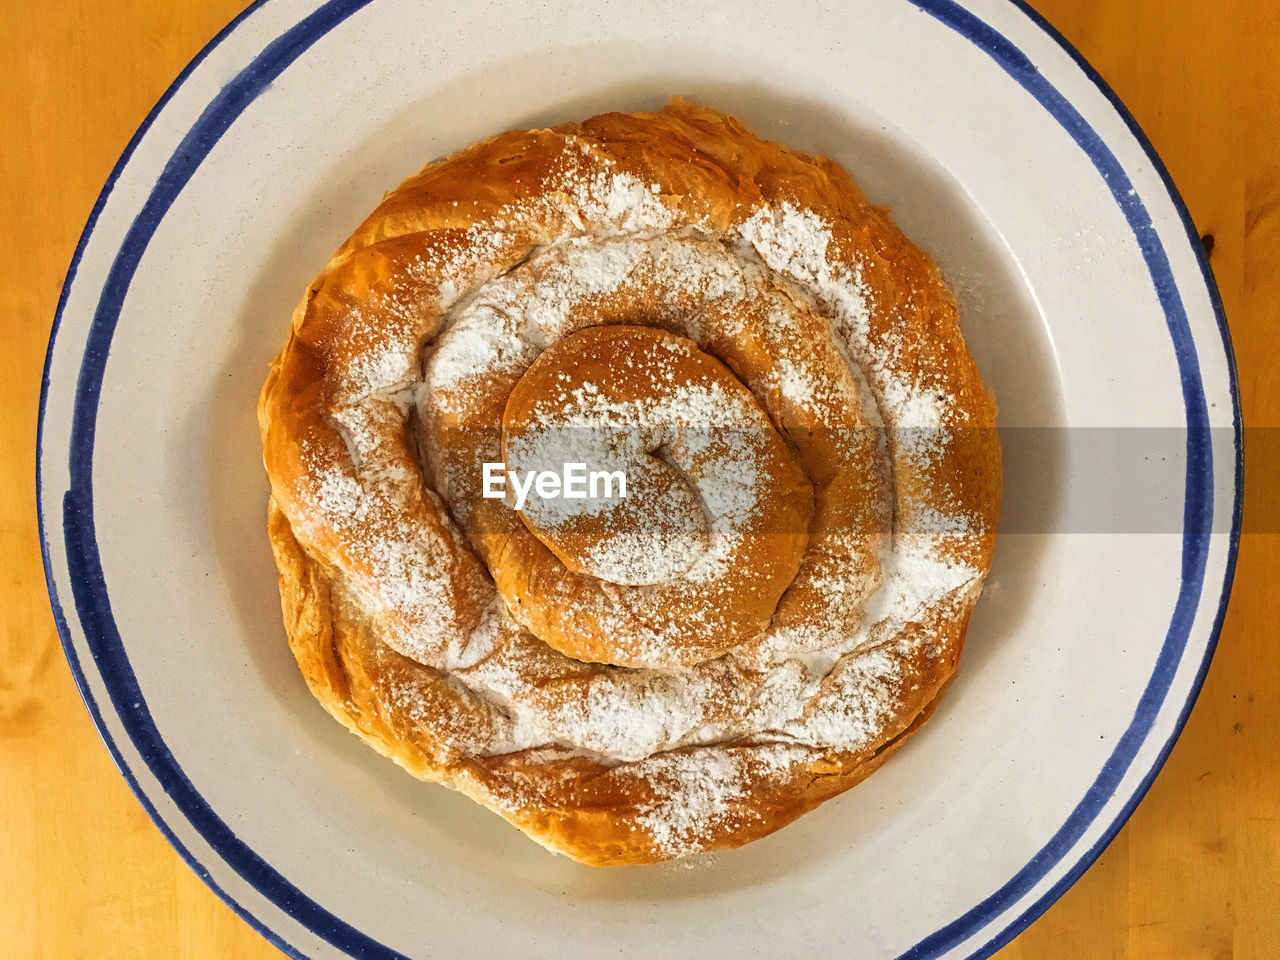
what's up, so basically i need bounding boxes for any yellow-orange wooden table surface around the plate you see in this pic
[0,0,1280,960]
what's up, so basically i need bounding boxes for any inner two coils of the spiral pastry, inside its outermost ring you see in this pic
[417,234,891,669]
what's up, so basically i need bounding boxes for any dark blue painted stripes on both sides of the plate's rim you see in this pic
[37,0,1242,960]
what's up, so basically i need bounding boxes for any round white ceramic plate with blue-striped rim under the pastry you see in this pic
[38,0,1239,960]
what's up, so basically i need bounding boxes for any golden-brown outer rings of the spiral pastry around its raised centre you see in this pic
[259,102,1000,864]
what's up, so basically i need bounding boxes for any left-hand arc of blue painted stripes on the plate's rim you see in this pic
[36,0,386,960]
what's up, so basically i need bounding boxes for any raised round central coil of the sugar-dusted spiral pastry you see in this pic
[499,324,813,666]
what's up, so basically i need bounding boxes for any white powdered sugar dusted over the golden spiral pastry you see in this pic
[288,145,982,855]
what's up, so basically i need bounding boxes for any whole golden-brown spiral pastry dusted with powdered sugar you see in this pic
[259,100,1001,864]
